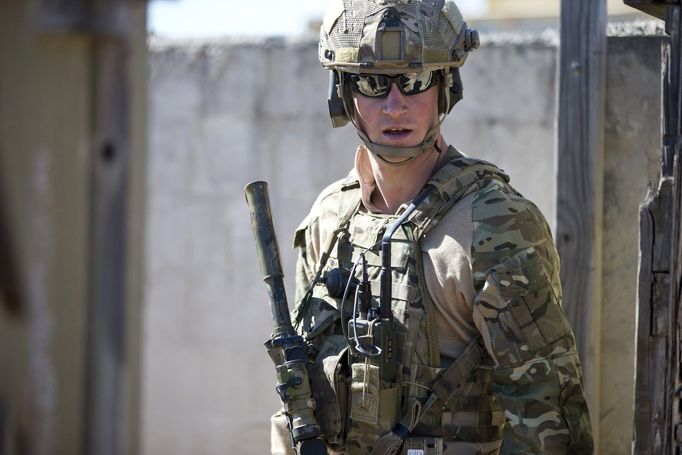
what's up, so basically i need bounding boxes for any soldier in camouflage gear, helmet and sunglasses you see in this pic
[272,0,592,455]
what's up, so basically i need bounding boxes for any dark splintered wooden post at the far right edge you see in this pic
[626,0,682,455]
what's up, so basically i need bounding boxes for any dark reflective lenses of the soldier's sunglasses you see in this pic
[350,71,436,98]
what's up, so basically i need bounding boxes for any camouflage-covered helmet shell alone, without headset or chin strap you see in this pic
[319,0,479,74]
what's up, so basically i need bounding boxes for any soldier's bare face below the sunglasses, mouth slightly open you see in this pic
[353,82,438,147]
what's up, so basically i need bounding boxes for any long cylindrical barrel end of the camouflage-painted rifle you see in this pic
[244,181,293,334]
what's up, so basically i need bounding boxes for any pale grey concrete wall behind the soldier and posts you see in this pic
[143,28,660,455]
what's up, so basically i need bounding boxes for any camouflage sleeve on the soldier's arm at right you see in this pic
[474,181,593,454]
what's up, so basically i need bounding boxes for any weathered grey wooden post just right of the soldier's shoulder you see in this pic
[555,0,606,443]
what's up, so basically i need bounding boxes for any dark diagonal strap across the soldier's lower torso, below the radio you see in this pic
[370,337,484,455]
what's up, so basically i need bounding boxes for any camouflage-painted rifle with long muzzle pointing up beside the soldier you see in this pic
[244,182,327,455]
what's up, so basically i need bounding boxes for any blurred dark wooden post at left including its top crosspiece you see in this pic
[40,0,139,455]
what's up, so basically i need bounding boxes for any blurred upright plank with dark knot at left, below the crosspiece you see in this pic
[85,33,129,455]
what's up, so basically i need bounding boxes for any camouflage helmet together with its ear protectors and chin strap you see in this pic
[318,0,479,162]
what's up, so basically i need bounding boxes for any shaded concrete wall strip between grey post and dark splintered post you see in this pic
[592,36,661,454]
